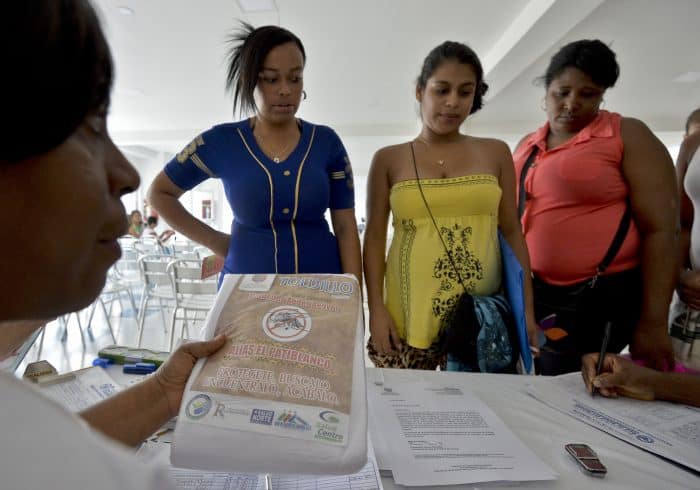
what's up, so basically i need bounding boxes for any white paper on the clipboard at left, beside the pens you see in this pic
[35,366,121,412]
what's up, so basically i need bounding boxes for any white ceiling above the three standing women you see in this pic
[95,0,700,172]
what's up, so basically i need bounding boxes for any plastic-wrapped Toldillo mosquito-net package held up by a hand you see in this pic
[172,274,367,475]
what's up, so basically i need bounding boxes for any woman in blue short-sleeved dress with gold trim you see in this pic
[149,24,362,280]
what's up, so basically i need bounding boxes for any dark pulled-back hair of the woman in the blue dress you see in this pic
[226,22,306,115]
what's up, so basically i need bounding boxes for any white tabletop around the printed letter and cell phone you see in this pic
[367,368,700,490]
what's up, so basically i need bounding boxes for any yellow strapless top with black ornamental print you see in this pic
[385,174,501,349]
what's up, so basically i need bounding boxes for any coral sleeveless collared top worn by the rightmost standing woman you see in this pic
[513,111,641,285]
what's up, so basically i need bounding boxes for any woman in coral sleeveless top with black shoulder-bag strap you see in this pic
[514,40,678,375]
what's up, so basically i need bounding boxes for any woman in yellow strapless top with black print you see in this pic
[364,41,536,369]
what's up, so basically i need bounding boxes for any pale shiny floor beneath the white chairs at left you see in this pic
[17,294,371,375]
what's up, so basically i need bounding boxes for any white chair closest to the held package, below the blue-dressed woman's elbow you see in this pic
[168,260,217,351]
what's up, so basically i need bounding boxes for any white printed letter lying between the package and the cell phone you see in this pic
[368,375,556,486]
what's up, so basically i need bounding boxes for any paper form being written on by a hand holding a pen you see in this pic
[528,373,700,471]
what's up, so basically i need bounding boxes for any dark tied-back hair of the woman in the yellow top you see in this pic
[416,41,489,114]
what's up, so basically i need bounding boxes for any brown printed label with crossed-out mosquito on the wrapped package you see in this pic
[184,274,360,446]
